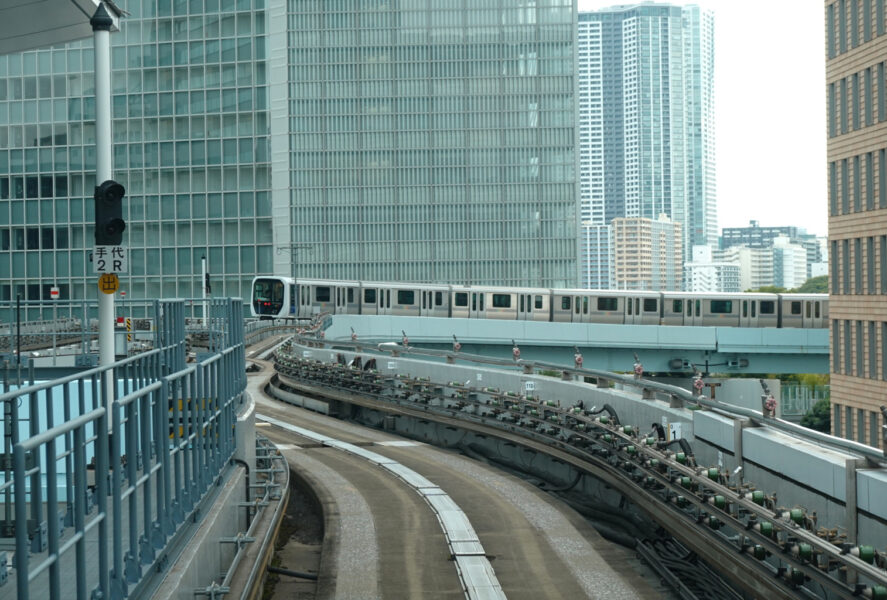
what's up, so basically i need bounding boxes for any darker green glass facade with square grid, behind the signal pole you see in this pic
[0,0,273,300]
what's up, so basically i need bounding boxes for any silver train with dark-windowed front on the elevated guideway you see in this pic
[250,275,828,329]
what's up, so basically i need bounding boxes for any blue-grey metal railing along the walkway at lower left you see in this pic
[0,299,246,600]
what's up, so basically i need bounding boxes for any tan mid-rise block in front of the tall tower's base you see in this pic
[612,215,684,291]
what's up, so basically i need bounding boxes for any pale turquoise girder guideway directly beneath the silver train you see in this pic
[323,315,829,374]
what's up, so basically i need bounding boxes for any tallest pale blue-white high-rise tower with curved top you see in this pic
[577,4,717,288]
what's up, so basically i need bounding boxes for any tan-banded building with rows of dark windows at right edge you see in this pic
[825,0,887,447]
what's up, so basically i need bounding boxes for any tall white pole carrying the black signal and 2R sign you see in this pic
[89,3,114,408]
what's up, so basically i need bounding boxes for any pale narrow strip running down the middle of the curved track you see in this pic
[256,414,505,600]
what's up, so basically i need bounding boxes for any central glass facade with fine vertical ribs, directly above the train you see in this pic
[269,0,579,286]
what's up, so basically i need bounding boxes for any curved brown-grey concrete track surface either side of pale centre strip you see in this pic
[250,360,665,599]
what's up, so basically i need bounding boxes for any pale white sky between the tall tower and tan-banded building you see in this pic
[579,0,828,236]
